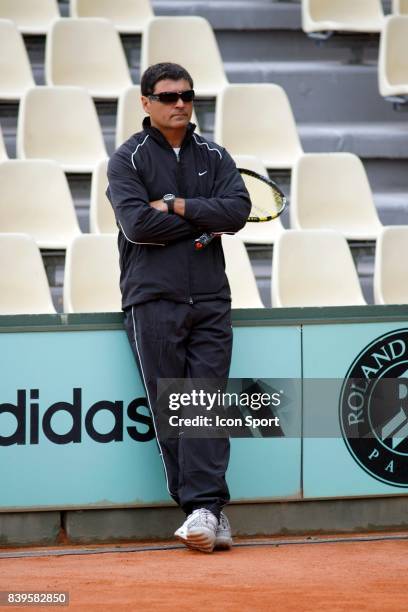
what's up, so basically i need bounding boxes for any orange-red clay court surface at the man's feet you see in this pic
[0,534,408,612]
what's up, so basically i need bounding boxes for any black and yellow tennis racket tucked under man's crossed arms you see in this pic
[194,168,287,251]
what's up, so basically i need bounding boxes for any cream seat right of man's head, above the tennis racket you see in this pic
[214,83,302,169]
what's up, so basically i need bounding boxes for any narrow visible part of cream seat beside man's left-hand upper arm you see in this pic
[89,159,118,234]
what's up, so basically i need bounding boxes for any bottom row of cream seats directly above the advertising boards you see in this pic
[0,226,408,315]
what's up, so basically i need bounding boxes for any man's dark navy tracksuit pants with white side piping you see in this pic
[124,299,232,518]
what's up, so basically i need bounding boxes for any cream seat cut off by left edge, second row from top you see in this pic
[0,19,35,100]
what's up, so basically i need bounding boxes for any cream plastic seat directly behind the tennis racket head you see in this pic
[234,155,285,244]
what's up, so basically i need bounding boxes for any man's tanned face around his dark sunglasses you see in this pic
[142,79,193,130]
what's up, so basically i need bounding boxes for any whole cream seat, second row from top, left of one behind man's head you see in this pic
[45,18,132,99]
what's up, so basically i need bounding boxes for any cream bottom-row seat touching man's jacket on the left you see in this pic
[64,234,121,312]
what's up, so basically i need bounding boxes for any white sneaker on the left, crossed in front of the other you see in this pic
[174,508,218,553]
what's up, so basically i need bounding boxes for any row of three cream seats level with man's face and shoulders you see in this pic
[0,83,303,173]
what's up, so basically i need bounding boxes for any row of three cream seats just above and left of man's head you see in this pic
[0,15,223,100]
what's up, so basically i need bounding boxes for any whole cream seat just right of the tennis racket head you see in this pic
[289,153,382,240]
